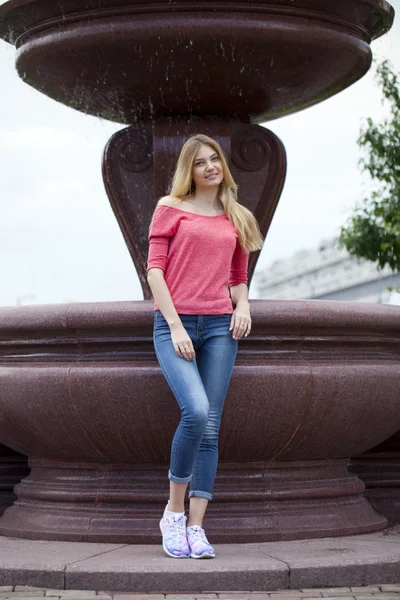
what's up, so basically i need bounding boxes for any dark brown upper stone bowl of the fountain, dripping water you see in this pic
[0,0,394,124]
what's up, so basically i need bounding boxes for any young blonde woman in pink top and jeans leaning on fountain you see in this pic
[147,135,263,558]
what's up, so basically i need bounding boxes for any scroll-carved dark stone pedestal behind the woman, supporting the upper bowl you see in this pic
[103,117,286,299]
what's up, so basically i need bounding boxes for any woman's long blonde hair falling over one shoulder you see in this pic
[164,134,264,252]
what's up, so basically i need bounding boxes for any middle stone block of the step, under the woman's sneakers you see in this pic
[65,544,289,594]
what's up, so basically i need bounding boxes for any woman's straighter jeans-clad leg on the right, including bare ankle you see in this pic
[188,315,238,527]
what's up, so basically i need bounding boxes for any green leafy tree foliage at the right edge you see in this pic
[339,60,400,272]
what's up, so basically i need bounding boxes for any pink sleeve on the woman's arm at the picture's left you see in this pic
[147,205,177,271]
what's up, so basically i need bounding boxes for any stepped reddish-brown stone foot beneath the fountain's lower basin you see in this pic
[0,459,387,544]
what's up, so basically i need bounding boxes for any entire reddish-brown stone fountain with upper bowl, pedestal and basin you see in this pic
[0,0,400,543]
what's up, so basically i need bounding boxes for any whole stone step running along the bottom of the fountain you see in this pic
[0,530,400,600]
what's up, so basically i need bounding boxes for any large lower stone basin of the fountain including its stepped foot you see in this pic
[0,300,400,543]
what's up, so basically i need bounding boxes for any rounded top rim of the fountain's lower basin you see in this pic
[0,298,400,341]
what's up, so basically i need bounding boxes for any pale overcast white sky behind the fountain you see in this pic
[0,0,400,306]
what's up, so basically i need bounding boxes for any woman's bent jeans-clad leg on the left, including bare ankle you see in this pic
[153,313,209,500]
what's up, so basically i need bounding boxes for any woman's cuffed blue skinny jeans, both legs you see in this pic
[153,310,238,500]
